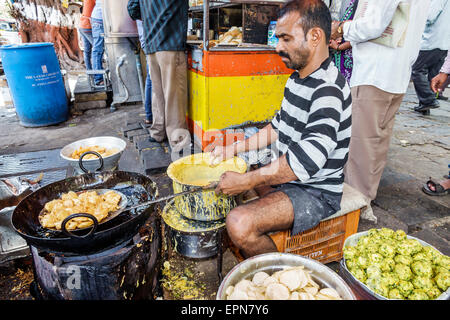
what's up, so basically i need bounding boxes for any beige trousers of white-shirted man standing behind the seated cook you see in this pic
[344,86,404,203]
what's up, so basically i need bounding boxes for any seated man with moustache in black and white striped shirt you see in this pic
[212,0,351,257]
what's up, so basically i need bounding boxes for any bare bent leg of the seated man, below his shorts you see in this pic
[226,192,294,258]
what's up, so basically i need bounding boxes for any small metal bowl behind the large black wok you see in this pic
[60,137,127,174]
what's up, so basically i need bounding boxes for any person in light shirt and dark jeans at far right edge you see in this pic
[411,0,450,114]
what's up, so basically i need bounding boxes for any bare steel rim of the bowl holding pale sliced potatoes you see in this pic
[216,252,356,300]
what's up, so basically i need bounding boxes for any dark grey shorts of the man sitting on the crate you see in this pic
[272,183,341,235]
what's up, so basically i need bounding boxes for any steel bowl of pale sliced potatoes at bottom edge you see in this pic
[216,252,356,300]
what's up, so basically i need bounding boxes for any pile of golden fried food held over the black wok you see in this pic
[39,190,122,230]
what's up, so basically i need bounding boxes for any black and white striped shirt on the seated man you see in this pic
[272,58,352,204]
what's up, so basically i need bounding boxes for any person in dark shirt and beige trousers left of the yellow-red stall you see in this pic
[141,0,191,152]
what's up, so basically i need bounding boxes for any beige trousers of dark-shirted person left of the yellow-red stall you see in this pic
[147,51,190,151]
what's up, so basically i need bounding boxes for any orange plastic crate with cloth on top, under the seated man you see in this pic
[269,183,366,263]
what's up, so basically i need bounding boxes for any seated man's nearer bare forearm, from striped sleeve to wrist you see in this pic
[246,155,298,188]
